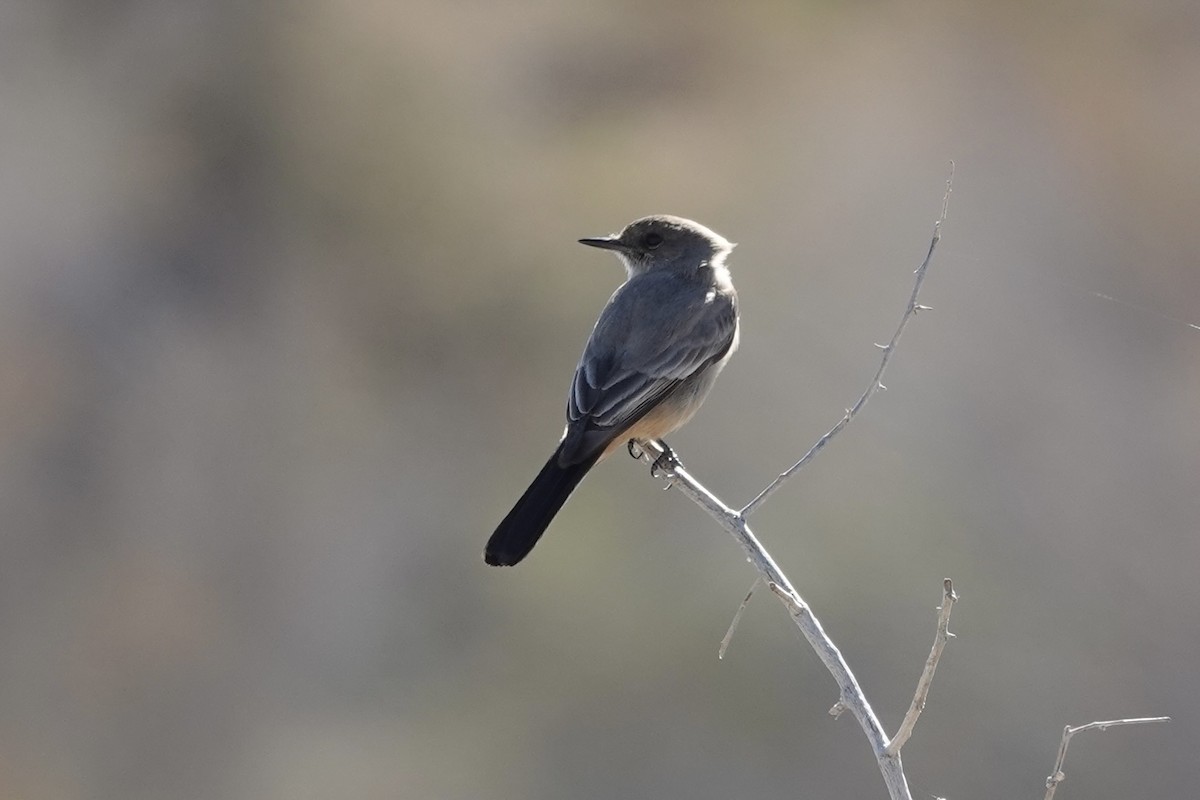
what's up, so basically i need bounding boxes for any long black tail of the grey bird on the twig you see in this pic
[484,451,600,566]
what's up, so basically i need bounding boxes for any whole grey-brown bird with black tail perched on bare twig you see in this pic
[484,215,739,566]
